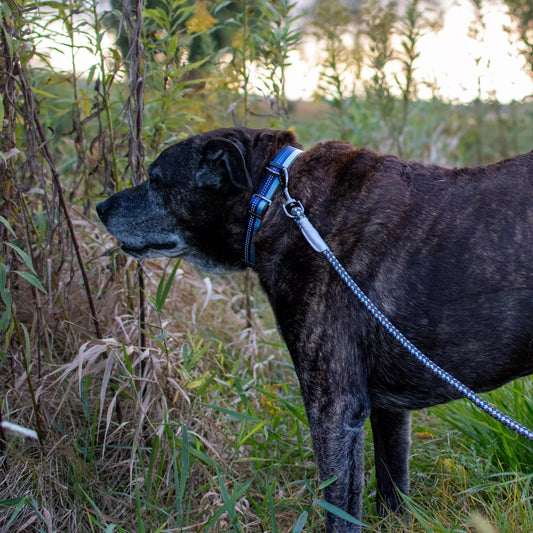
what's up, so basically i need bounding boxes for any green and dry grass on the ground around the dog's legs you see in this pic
[0,238,533,532]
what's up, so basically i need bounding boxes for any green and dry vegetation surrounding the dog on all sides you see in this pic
[0,0,533,532]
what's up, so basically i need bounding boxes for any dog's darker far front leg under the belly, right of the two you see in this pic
[370,407,411,516]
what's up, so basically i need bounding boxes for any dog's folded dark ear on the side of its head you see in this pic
[196,139,253,190]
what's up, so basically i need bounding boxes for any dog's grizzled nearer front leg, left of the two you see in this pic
[304,382,370,533]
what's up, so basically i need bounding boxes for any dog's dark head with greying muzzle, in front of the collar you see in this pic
[96,128,298,272]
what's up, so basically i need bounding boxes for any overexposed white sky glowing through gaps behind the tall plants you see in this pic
[40,0,533,102]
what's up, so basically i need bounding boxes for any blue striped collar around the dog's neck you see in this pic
[242,146,303,266]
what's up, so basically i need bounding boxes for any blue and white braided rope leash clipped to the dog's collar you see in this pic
[248,147,533,441]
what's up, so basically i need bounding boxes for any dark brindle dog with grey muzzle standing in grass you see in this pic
[97,128,533,532]
